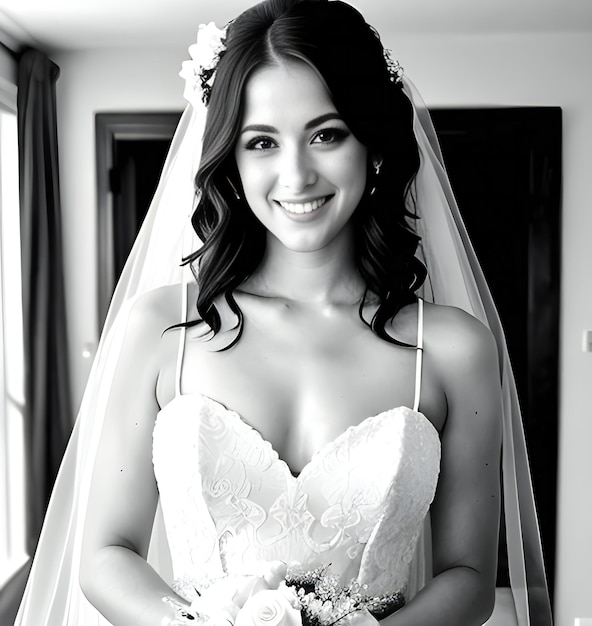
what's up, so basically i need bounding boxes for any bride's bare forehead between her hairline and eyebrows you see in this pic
[243,61,336,123]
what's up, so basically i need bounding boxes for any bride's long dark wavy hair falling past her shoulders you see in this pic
[186,0,426,345]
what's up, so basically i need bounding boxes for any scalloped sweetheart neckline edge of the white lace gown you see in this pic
[155,391,440,472]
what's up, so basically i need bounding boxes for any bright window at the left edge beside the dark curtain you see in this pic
[0,106,27,587]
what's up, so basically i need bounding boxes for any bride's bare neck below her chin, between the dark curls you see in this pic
[245,229,364,304]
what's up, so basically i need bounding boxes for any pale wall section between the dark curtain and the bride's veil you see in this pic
[54,46,186,402]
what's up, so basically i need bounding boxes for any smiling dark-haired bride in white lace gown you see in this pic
[17,0,544,626]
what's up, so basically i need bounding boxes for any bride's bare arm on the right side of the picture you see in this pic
[387,307,502,626]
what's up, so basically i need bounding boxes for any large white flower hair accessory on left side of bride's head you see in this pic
[179,22,226,107]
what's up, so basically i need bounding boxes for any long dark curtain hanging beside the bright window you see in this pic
[0,50,73,624]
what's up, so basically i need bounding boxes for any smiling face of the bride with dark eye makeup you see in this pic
[235,62,367,252]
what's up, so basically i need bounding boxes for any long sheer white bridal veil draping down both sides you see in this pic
[15,68,552,626]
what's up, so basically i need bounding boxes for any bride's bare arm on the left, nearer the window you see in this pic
[80,292,186,626]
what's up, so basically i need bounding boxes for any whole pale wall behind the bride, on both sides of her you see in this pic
[55,33,592,626]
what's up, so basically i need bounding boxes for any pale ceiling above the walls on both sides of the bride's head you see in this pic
[0,0,592,51]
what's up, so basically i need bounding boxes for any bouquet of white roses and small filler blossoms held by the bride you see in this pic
[191,561,404,626]
